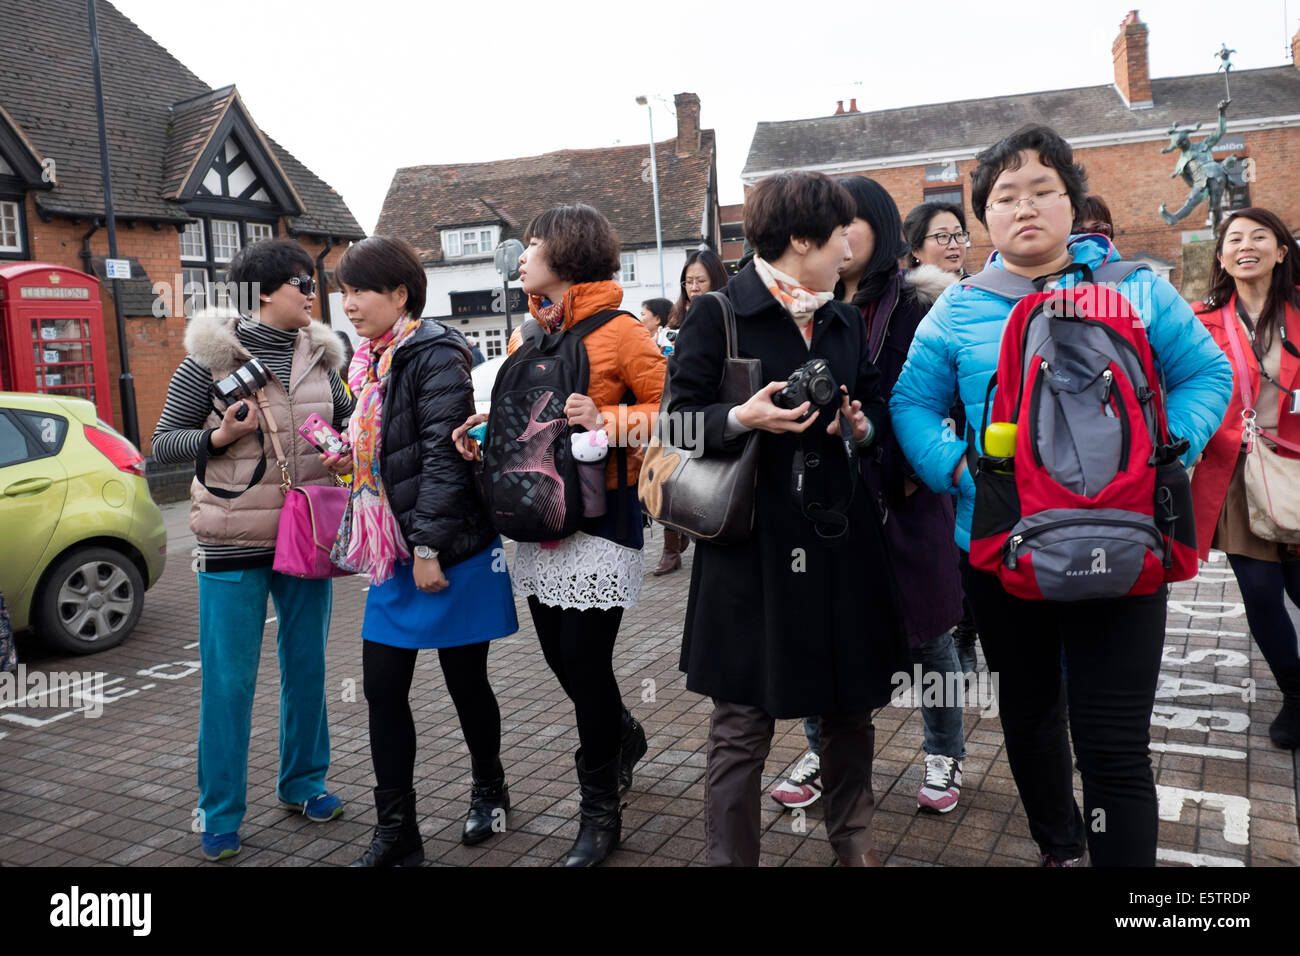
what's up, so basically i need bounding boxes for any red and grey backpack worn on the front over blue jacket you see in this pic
[965,261,1196,601]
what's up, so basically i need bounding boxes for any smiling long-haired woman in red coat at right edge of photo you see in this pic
[1192,207,1300,750]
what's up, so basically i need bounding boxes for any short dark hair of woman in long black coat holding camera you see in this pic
[745,172,857,261]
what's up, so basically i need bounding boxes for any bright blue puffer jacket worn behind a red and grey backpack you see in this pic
[889,235,1232,550]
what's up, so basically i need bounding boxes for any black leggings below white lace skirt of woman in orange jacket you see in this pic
[528,594,623,767]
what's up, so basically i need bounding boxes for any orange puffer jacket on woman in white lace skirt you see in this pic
[508,280,668,490]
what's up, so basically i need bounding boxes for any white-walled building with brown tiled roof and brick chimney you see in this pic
[374,92,722,358]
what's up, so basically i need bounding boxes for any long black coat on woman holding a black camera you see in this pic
[668,267,910,717]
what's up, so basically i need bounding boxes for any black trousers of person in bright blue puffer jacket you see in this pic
[961,551,1167,866]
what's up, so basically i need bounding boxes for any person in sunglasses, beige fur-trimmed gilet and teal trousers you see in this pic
[153,239,352,860]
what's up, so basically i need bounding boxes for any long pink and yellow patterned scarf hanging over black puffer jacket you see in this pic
[330,315,420,584]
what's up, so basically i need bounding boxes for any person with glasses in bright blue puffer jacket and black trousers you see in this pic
[891,126,1232,866]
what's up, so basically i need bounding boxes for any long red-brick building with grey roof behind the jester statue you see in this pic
[742,10,1300,294]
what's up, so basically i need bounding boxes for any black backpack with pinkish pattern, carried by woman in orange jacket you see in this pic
[477,310,631,541]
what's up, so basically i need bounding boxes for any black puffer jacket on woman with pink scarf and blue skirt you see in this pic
[380,320,497,568]
